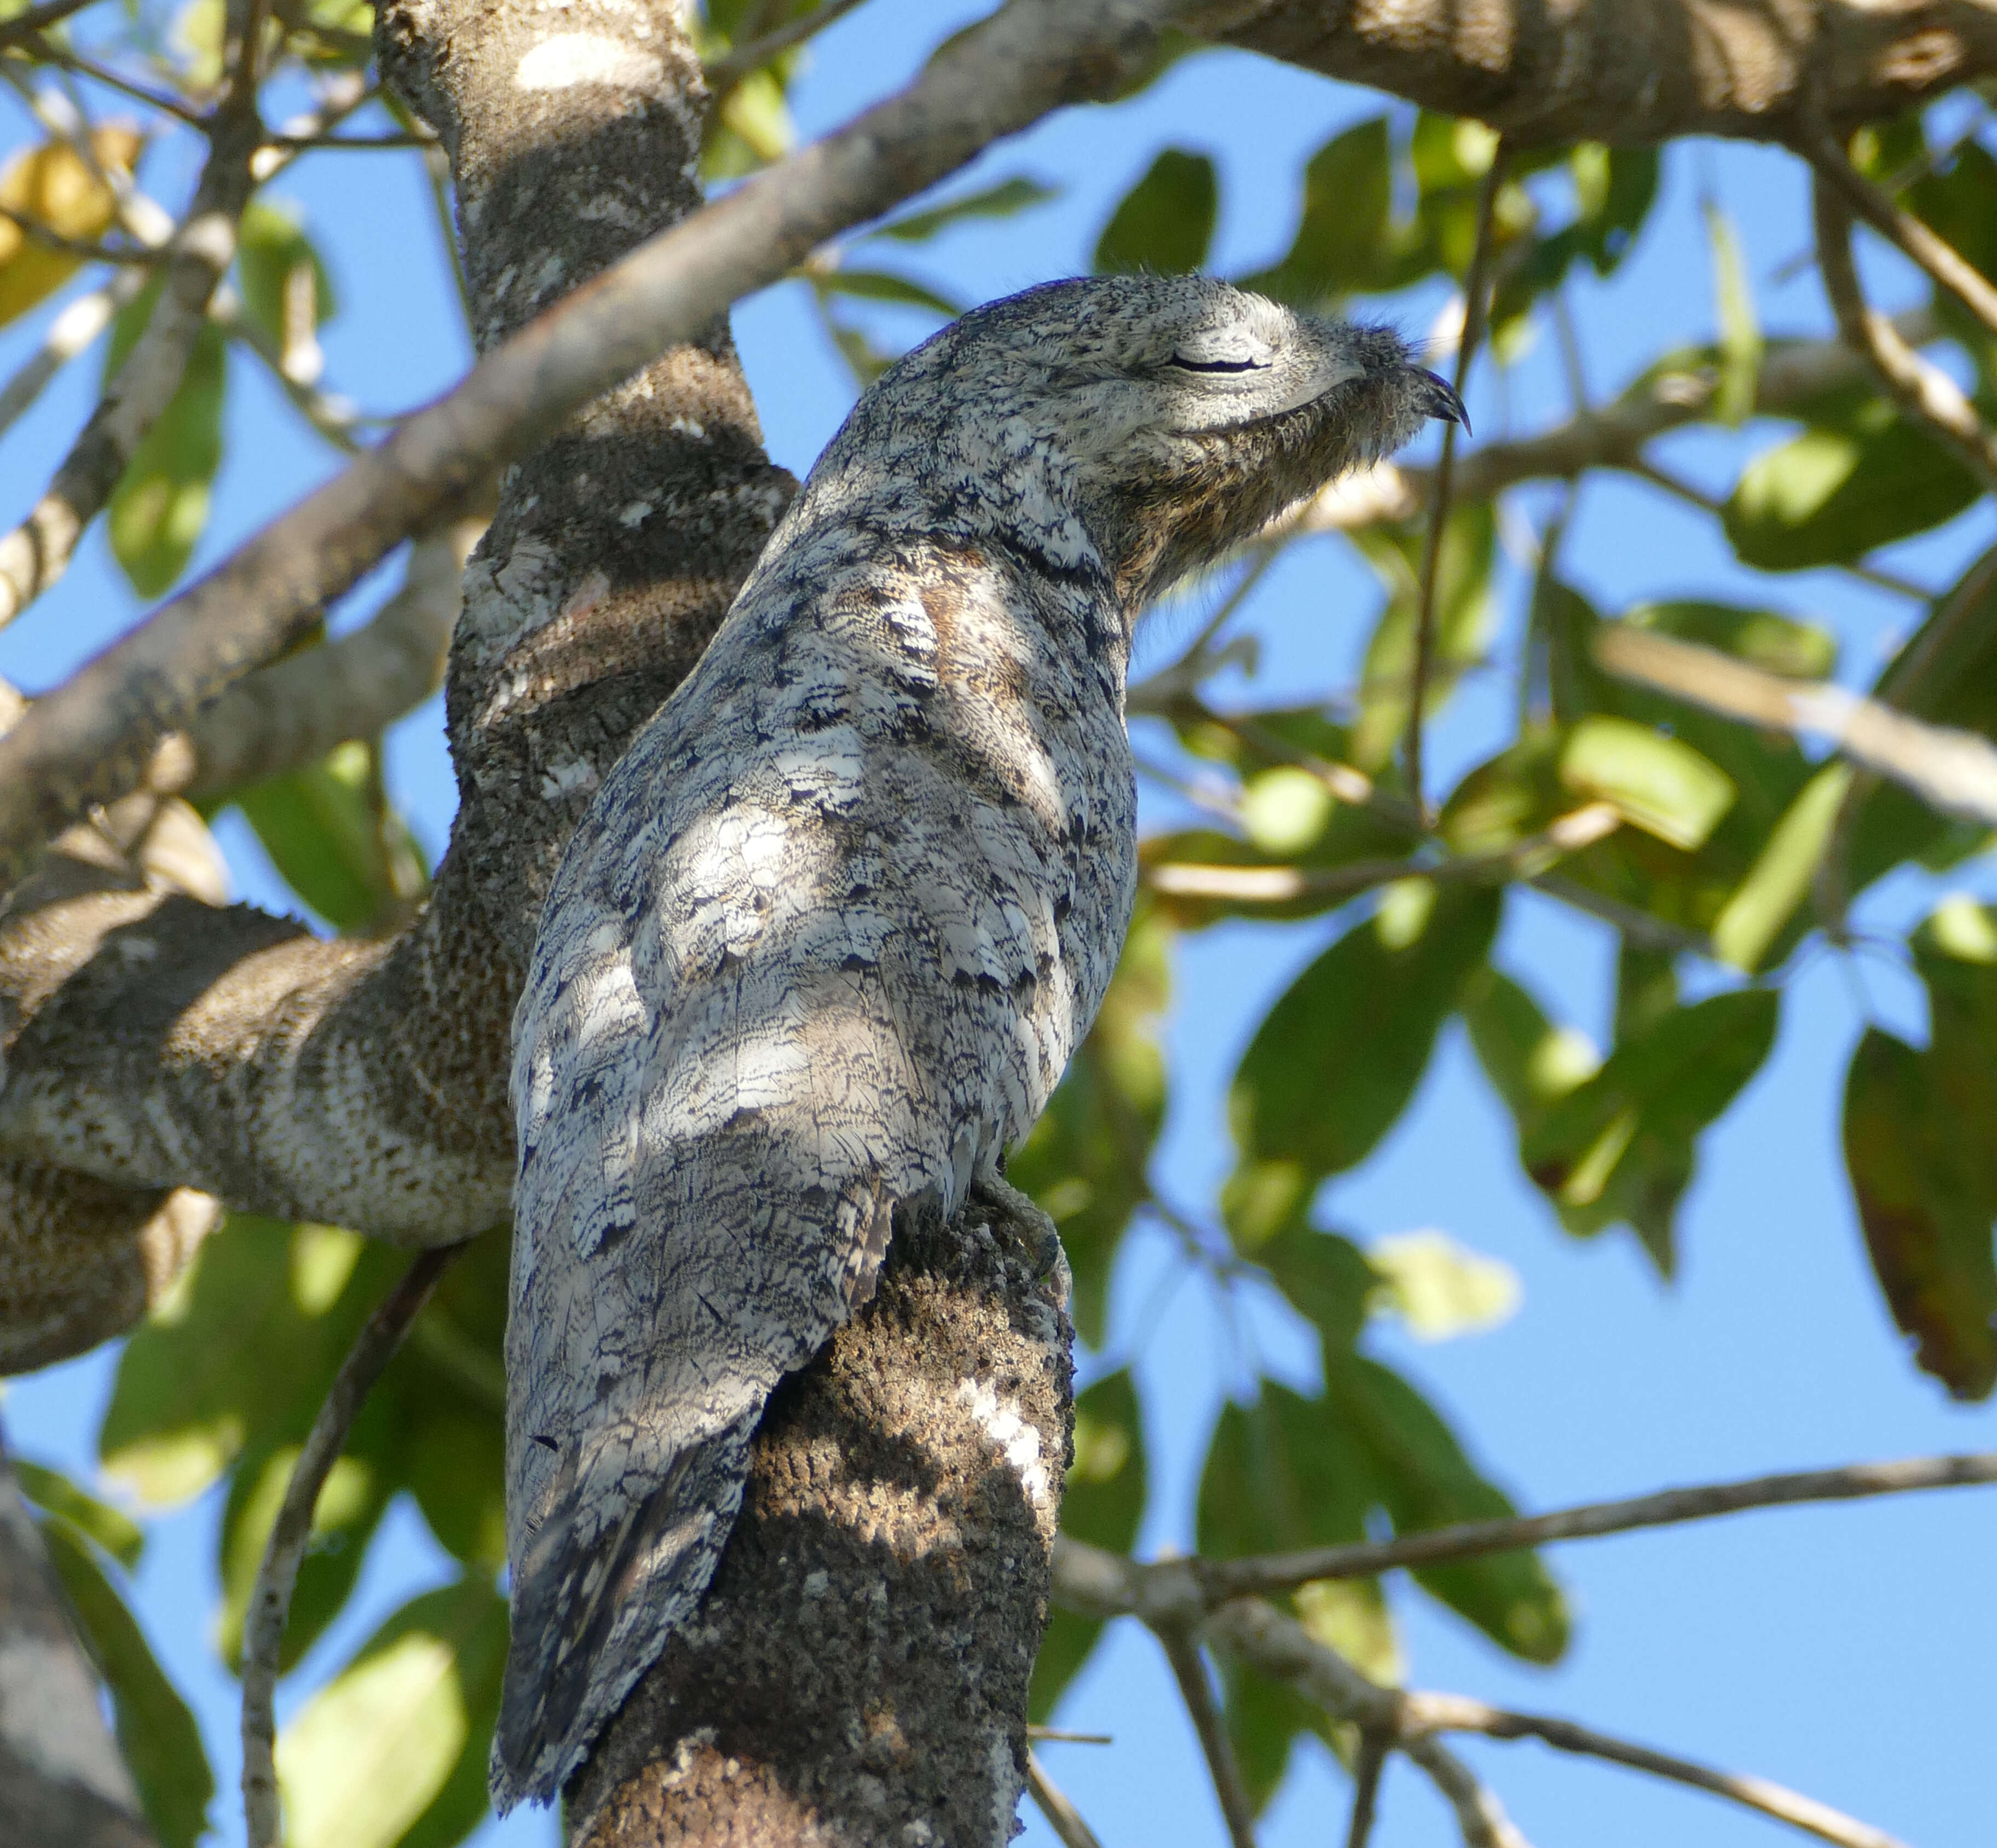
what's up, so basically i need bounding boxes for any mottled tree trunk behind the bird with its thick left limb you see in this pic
[0,0,791,1326]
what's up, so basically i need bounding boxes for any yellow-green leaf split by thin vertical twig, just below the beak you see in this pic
[1352,501,1498,775]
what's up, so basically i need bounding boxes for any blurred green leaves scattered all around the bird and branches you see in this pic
[0,0,1997,1848]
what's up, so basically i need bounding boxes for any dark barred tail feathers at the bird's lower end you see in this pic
[491,1406,763,1814]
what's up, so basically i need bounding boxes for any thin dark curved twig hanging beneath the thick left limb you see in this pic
[241,1245,465,1848]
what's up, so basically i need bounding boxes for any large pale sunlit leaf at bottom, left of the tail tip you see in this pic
[278,1580,507,1848]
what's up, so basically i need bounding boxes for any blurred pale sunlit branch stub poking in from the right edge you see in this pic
[1596,623,1997,823]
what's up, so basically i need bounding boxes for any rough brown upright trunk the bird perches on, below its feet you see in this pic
[567,1218,1072,1848]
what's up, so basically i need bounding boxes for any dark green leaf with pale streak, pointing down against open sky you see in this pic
[1520,989,1777,1269]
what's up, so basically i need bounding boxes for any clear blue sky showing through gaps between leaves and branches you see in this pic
[0,0,1997,1848]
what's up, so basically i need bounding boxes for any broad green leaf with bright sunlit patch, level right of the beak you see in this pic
[1723,408,1979,571]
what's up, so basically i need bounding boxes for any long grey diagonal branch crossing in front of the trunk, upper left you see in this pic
[0,0,1246,877]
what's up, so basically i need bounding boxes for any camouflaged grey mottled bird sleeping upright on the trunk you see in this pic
[493,276,1462,1810]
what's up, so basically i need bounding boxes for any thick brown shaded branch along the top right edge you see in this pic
[1226,0,1997,146]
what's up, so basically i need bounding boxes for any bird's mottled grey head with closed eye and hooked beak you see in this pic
[834,276,1464,611]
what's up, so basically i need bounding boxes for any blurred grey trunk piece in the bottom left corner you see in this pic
[0,1451,156,1848]
